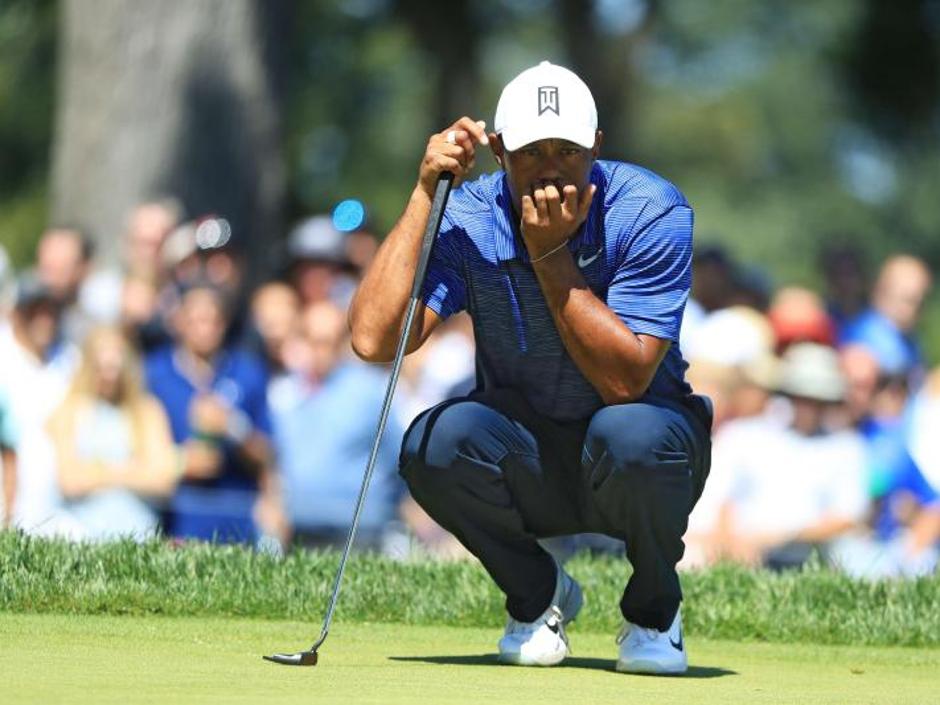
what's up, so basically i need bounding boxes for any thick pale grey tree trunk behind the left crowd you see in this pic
[51,0,287,274]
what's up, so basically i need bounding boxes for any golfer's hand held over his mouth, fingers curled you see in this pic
[521,184,597,260]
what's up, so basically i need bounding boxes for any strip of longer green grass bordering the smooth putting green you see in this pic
[0,532,940,646]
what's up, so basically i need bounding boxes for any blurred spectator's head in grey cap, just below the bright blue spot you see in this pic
[287,215,357,307]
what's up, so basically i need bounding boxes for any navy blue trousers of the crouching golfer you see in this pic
[400,390,711,630]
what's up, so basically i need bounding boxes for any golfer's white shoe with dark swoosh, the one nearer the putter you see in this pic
[499,565,584,666]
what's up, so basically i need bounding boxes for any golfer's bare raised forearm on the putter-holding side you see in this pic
[349,188,431,361]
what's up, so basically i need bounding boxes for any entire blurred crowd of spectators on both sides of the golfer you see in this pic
[0,200,940,577]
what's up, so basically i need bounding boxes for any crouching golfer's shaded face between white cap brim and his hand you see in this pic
[490,131,602,213]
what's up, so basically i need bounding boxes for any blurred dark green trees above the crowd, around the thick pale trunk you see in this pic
[0,0,940,350]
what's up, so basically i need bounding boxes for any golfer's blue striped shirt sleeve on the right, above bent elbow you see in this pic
[607,205,693,342]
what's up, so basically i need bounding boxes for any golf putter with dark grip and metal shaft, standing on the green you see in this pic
[263,171,454,666]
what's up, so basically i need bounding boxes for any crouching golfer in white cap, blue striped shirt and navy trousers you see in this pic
[350,62,711,673]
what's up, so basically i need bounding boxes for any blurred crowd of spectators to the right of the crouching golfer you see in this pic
[681,247,940,577]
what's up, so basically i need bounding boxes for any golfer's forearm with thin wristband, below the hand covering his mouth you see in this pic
[533,248,661,404]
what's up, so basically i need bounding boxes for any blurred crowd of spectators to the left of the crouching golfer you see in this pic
[0,200,474,555]
